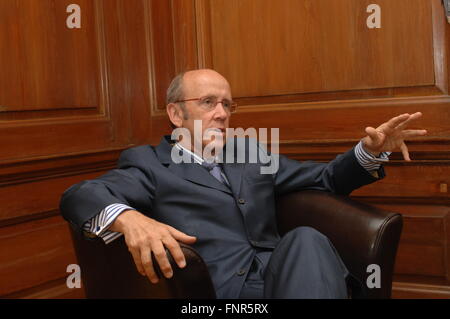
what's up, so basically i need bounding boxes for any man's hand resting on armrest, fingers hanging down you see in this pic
[109,210,197,284]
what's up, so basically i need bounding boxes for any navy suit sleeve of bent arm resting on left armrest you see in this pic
[60,149,156,235]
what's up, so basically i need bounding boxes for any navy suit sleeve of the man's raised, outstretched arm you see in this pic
[270,148,385,195]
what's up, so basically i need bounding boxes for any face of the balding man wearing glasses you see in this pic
[177,70,232,156]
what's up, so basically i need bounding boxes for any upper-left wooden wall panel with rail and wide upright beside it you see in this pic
[0,0,155,163]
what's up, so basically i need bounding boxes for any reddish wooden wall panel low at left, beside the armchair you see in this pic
[0,216,77,295]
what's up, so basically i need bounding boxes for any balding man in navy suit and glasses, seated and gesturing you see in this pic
[61,70,426,298]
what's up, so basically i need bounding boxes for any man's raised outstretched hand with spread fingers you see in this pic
[362,112,427,161]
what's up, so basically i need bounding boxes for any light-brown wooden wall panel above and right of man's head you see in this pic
[206,0,434,97]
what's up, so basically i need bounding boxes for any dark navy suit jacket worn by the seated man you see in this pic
[61,136,384,298]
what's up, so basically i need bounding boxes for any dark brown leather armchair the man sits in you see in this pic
[72,191,402,299]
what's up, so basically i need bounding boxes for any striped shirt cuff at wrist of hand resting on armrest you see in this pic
[83,204,133,244]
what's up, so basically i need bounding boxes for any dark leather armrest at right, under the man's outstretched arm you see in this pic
[277,190,402,298]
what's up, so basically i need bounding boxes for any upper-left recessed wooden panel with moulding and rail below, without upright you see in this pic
[0,0,115,161]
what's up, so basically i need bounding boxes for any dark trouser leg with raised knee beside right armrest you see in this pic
[264,227,348,298]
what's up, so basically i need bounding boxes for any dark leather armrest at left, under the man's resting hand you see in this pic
[71,228,216,299]
